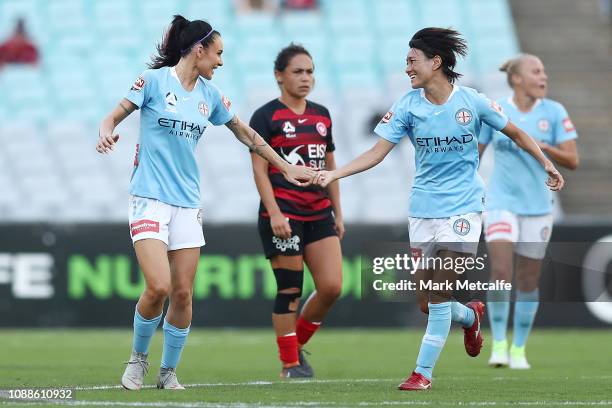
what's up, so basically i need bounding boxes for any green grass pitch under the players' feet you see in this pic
[0,326,612,408]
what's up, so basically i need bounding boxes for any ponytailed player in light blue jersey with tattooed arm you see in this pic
[96,15,314,390]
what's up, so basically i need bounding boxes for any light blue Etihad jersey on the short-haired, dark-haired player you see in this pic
[374,86,508,218]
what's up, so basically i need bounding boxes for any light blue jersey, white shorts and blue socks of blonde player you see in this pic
[479,97,578,347]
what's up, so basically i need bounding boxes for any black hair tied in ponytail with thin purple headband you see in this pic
[148,14,221,69]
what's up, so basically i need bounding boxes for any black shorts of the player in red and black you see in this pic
[257,214,338,259]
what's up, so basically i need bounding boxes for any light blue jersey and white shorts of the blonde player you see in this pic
[479,98,577,259]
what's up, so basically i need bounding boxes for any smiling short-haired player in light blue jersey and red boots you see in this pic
[315,27,563,390]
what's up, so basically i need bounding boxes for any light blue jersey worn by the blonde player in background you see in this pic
[479,98,578,215]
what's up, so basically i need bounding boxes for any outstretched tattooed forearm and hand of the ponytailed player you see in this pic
[225,115,316,186]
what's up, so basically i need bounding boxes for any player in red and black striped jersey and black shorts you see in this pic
[250,44,344,378]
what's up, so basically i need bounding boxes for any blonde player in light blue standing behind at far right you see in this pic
[478,54,578,369]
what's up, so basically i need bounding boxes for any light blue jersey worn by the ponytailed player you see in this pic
[126,67,234,208]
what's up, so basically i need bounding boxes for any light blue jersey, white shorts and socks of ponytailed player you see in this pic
[126,67,233,368]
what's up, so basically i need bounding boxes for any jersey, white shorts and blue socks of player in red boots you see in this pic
[374,86,508,379]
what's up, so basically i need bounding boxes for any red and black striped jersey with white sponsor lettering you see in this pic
[249,99,335,221]
